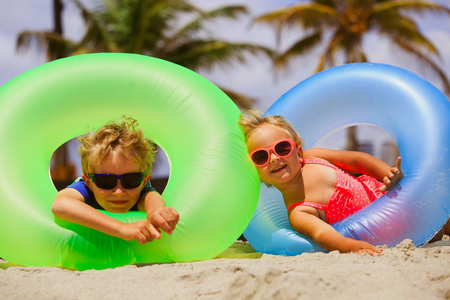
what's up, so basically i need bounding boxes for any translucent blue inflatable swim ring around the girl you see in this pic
[244,63,450,255]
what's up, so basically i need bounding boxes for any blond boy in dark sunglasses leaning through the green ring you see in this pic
[52,118,179,244]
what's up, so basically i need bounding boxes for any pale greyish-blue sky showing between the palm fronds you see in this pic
[0,0,450,178]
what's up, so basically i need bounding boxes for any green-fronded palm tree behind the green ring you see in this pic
[18,0,272,109]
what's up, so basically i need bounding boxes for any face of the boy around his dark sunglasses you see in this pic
[83,154,150,213]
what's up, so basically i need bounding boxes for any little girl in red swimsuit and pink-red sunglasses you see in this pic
[239,111,403,255]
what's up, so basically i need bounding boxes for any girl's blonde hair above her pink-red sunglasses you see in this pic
[238,110,303,149]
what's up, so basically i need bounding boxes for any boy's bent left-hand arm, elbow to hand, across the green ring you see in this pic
[52,188,153,244]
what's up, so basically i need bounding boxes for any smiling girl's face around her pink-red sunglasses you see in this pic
[247,124,303,187]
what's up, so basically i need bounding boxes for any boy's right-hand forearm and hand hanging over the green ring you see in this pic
[138,191,179,239]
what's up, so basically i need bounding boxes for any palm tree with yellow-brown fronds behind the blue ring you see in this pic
[254,0,450,150]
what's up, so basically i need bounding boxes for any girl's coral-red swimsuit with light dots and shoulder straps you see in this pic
[288,159,384,224]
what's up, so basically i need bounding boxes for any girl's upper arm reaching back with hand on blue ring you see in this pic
[304,148,403,192]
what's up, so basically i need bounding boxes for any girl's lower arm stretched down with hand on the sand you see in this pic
[289,207,382,256]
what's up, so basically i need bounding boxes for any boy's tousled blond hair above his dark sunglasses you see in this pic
[78,117,156,175]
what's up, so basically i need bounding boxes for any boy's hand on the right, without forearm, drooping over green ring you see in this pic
[147,207,180,239]
